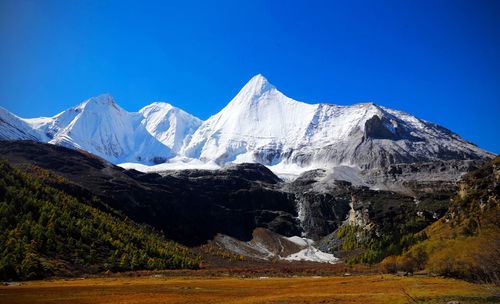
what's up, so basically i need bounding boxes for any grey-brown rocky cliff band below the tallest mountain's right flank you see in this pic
[283,160,484,240]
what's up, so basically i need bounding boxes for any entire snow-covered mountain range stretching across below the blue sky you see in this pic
[0,75,494,172]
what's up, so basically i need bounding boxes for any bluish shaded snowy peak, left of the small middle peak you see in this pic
[26,95,175,162]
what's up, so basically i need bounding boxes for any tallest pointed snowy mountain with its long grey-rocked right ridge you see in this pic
[182,75,493,170]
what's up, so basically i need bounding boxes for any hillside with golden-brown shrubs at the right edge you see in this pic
[384,157,500,285]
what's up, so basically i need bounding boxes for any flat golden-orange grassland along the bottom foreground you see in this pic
[0,274,500,304]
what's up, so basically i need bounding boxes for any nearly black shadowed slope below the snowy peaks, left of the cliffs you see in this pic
[0,141,300,246]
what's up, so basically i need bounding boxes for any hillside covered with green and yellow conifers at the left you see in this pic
[0,160,200,280]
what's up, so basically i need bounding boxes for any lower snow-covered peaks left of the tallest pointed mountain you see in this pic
[1,94,200,164]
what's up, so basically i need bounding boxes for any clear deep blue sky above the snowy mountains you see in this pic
[0,0,500,153]
